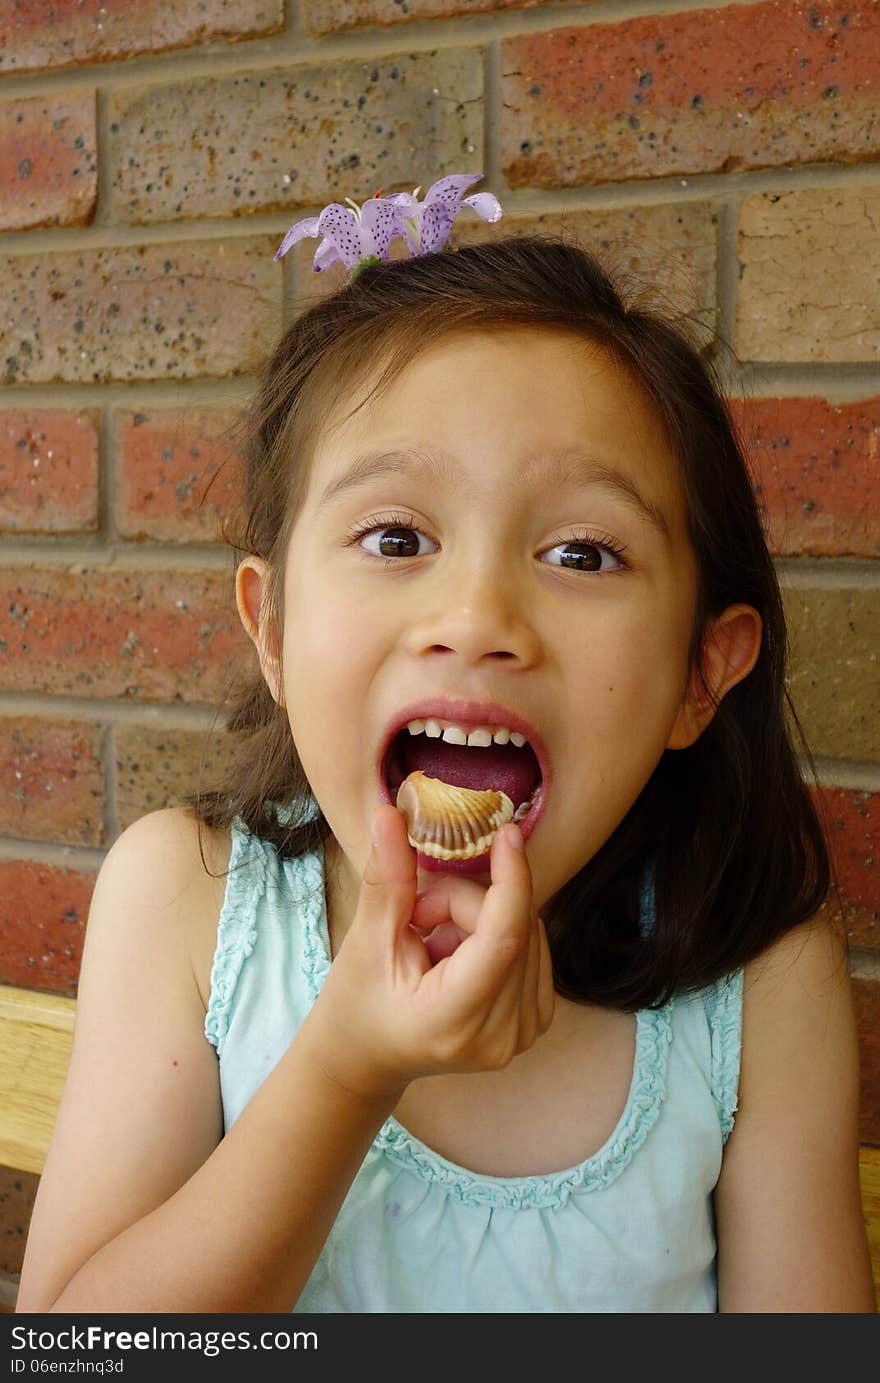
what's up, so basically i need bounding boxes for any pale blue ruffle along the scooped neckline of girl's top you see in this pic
[296,874,672,1209]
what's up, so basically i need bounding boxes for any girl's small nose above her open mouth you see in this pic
[407,567,540,667]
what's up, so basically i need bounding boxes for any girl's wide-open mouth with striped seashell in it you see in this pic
[382,718,544,871]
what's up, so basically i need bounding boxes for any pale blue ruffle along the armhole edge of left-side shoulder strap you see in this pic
[205,817,266,1055]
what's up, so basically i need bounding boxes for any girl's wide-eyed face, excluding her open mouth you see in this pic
[246,328,696,910]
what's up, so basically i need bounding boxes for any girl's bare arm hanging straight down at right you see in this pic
[715,918,876,1312]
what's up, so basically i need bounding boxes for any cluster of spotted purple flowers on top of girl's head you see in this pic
[275,173,502,278]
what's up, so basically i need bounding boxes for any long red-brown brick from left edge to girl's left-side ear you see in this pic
[0,566,252,705]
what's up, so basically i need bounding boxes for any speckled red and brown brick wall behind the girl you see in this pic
[0,0,880,1304]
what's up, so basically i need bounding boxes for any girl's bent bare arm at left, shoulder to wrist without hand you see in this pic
[17,809,394,1312]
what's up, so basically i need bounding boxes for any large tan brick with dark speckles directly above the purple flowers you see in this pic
[108,48,483,226]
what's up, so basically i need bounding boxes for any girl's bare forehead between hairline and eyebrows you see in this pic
[303,332,686,545]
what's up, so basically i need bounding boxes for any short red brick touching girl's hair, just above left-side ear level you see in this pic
[116,408,244,542]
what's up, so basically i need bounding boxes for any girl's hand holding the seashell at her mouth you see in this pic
[307,805,553,1098]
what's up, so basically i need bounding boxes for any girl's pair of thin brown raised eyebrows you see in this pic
[318,447,672,545]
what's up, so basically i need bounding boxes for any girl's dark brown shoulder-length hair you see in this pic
[191,235,830,1011]
